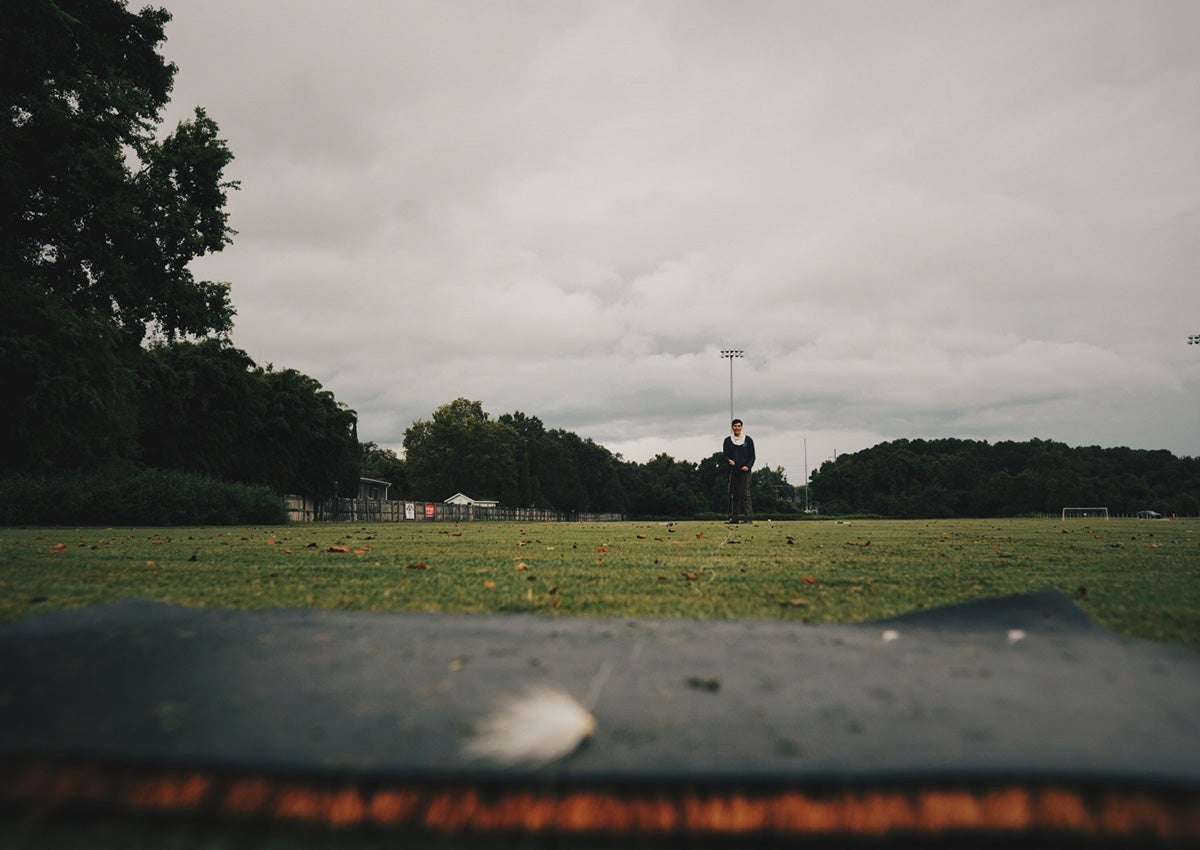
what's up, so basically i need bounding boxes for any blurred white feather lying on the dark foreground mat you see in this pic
[463,687,596,765]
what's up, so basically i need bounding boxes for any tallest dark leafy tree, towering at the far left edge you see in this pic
[0,0,234,468]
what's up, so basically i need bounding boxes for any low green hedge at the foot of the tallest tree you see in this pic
[0,469,288,526]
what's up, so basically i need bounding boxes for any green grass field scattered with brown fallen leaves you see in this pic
[0,520,1200,646]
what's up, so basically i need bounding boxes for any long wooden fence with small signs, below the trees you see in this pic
[284,496,625,522]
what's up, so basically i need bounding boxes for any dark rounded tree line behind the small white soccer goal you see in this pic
[810,439,1200,517]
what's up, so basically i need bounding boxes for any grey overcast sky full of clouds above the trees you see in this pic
[154,0,1200,484]
